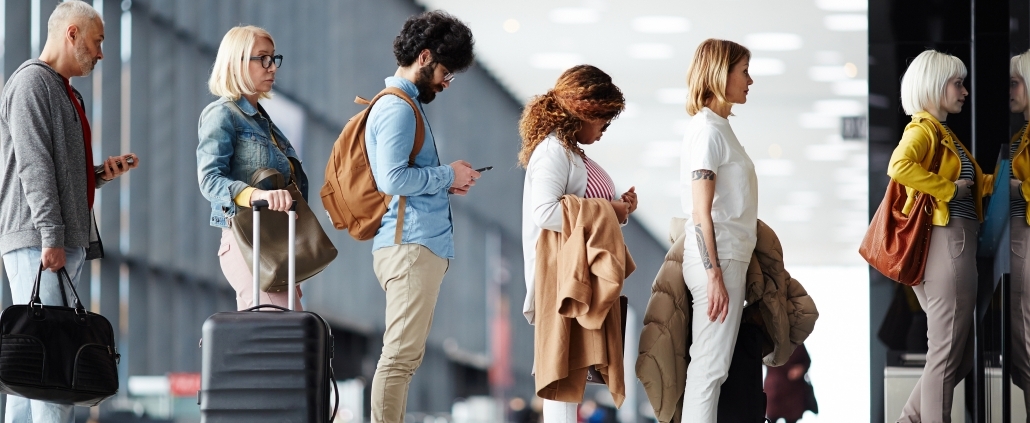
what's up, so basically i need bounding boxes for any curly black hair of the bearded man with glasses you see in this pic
[393,10,476,73]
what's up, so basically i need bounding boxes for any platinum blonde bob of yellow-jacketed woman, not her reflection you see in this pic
[901,50,967,115]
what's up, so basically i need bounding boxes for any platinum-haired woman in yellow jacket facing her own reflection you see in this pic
[887,50,993,423]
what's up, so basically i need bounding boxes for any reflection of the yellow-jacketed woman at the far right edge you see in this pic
[1008,51,1030,422]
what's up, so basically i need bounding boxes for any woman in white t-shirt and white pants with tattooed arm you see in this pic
[680,39,758,423]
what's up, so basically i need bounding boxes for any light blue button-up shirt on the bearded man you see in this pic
[365,76,454,258]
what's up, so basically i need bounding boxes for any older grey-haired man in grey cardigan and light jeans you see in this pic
[0,0,139,423]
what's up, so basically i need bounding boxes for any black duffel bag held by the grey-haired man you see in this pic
[0,263,119,407]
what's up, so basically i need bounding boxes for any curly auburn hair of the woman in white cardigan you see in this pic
[518,65,626,168]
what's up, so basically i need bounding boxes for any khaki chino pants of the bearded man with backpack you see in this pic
[372,244,449,423]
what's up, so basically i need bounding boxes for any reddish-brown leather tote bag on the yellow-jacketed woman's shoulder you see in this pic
[858,141,946,286]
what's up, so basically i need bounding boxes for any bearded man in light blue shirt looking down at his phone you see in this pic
[365,11,479,423]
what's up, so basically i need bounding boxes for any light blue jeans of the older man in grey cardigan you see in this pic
[3,247,85,423]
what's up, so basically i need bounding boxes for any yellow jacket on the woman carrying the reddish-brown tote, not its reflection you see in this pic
[887,111,994,226]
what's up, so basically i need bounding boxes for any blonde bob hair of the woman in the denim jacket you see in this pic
[207,26,275,101]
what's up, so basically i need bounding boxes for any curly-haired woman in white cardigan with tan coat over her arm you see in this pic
[518,65,637,423]
